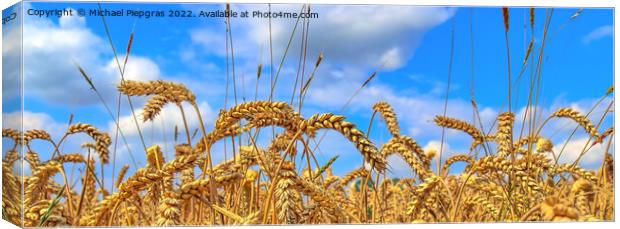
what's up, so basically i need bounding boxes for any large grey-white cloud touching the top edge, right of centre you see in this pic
[274,5,456,69]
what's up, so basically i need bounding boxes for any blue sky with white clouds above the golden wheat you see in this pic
[3,3,613,182]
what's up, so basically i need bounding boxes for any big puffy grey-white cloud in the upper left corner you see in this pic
[3,7,161,105]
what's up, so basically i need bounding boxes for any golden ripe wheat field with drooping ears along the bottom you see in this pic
[2,5,615,227]
